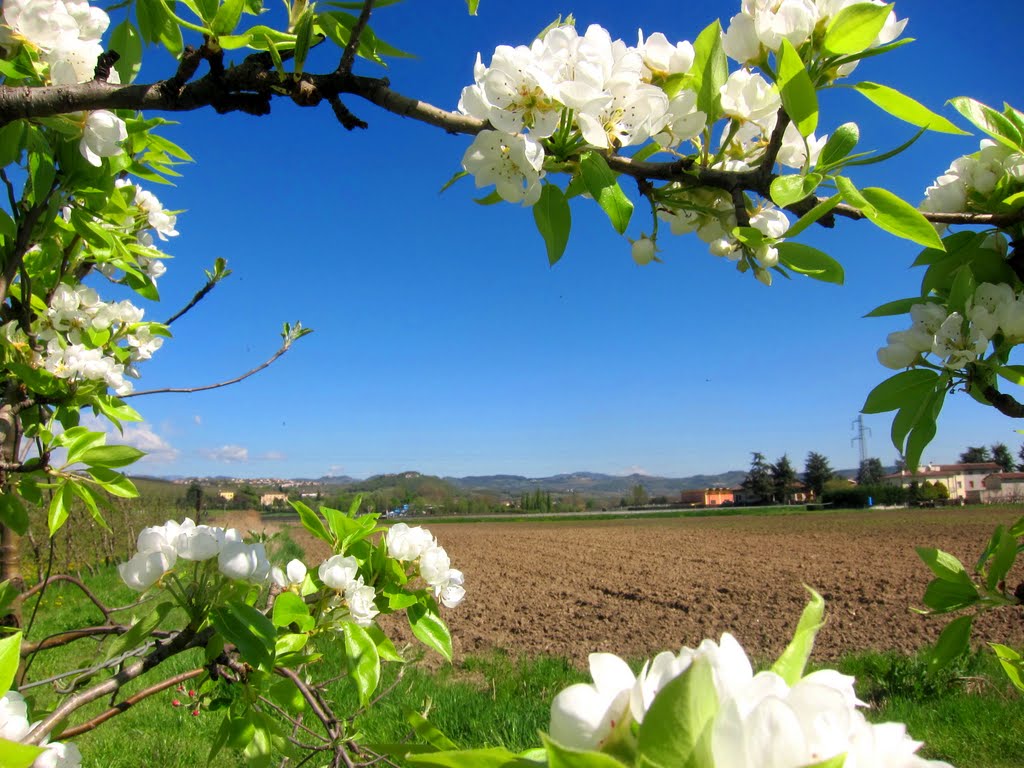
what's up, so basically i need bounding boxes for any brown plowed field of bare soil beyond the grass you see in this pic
[278,508,1024,659]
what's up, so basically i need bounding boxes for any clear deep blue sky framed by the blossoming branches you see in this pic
[105,0,1021,477]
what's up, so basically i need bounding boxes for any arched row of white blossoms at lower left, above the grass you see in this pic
[118,517,270,592]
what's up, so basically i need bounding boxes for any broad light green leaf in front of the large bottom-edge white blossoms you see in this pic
[637,656,719,768]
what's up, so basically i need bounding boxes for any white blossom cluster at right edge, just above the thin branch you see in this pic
[920,138,1024,218]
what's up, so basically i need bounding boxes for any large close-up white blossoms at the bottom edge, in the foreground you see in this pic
[550,633,948,768]
